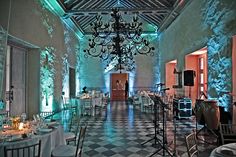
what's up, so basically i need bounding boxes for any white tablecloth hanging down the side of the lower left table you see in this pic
[0,125,65,157]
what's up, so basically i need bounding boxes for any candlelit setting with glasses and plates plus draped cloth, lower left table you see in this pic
[0,115,65,157]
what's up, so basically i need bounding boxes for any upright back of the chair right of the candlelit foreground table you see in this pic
[75,125,87,157]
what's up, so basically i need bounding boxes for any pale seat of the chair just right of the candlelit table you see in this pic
[52,145,76,157]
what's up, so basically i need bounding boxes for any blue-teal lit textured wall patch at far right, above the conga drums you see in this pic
[203,0,235,111]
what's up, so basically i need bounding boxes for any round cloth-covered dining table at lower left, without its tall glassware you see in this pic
[0,122,66,157]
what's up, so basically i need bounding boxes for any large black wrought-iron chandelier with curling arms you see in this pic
[84,8,154,71]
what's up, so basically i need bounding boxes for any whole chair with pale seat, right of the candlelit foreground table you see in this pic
[51,126,87,157]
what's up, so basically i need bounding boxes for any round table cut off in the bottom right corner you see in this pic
[210,143,236,157]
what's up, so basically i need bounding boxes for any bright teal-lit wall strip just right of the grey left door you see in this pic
[40,47,55,112]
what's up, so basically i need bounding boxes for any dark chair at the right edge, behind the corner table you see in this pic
[220,123,236,144]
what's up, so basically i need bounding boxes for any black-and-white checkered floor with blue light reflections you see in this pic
[58,101,216,157]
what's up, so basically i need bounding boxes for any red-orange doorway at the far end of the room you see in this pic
[110,73,129,101]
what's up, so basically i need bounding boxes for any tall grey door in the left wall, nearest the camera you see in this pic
[5,46,26,116]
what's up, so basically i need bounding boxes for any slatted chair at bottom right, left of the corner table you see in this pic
[185,132,199,157]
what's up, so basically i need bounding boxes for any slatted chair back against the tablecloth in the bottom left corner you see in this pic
[4,140,41,157]
